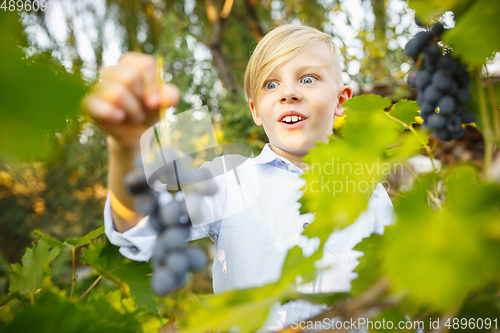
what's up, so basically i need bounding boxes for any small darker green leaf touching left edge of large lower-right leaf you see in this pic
[351,234,384,296]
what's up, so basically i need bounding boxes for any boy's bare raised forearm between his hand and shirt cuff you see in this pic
[107,137,144,232]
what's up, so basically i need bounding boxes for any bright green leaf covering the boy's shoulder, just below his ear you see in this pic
[300,95,398,239]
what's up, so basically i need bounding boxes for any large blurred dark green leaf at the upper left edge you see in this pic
[0,10,86,160]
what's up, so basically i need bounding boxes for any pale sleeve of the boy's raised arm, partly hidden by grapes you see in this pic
[104,157,226,261]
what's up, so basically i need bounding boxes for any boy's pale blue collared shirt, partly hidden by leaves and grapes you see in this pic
[104,144,395,331]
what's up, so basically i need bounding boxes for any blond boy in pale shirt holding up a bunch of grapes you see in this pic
[84,25,393,331]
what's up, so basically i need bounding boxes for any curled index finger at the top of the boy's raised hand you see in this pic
[120,53,160,109]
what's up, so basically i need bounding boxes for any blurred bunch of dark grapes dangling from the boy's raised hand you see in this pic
[124,155,217,297]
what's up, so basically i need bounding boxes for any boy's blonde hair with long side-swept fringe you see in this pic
[245,24,343,103]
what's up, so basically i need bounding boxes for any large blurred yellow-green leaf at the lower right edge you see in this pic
[382,167,500,311]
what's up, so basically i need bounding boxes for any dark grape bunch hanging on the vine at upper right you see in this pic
[405,22,476,141]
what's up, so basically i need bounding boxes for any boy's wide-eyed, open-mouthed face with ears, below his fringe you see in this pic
[249,42,352,155]
